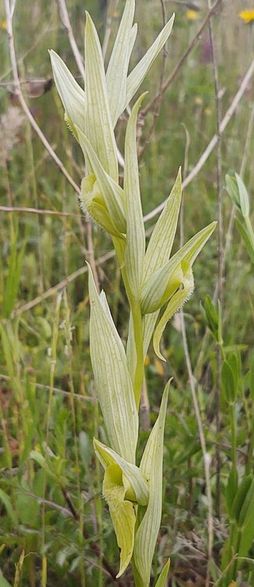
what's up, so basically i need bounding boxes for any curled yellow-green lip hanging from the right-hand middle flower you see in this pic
[153,271,194,361]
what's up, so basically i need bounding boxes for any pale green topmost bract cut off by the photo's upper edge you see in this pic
[106,0,137,127]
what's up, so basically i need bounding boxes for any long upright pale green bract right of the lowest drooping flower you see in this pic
[133,383,169,587]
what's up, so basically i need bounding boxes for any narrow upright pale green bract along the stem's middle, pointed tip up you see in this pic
[124,94,145,299]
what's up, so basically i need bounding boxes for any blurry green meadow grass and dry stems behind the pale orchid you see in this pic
[0,0,254,587]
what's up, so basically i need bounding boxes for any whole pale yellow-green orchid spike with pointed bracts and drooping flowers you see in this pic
[50,0,215,587]
